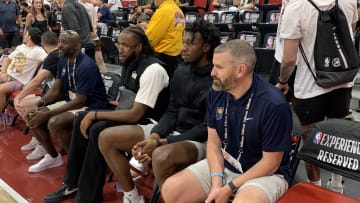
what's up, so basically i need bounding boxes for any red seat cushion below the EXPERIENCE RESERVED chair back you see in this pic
[277,182,360,203]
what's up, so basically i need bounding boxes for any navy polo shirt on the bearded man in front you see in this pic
[207,74,292,180]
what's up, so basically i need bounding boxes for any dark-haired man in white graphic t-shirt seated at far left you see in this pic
[0,27,47,110]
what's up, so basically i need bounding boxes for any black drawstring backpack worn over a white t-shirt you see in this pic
[299,0,360,88]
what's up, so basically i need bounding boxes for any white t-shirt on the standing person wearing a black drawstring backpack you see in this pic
[280,0,358,99]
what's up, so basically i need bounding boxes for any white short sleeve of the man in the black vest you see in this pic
[135,63,169,108]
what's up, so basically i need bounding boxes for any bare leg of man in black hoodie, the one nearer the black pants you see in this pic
[99,125,144,192]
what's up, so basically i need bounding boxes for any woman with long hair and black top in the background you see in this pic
[25,0,50,33]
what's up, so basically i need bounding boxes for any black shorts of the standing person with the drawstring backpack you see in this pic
[294,88,352,125]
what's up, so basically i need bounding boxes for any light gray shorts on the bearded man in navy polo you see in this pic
[187,159,289,203]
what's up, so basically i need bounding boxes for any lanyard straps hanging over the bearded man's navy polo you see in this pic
[223,93,254,161]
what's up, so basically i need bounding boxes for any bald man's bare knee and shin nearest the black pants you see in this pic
[48,112,75,152]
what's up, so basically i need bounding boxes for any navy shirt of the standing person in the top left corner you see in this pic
[0,0,20,32]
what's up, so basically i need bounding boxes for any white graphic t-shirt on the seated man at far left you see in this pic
[7,44,47,85]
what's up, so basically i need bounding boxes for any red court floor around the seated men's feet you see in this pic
[0,106,154,203]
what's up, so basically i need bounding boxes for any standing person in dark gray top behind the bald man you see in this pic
[62,0,95,60]
